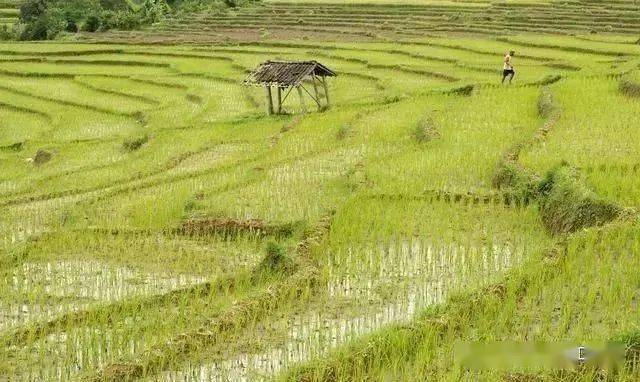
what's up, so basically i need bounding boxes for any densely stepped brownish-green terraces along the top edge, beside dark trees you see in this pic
[89,0,640,42]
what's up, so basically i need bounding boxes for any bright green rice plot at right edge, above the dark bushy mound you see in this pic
[523,79,640,206]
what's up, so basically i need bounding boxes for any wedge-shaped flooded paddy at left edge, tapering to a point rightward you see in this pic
[0,260,206,330]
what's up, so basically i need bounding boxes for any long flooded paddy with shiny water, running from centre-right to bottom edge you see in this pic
[151,240,524,382]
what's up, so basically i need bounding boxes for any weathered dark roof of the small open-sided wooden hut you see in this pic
[244,61,336,86]
